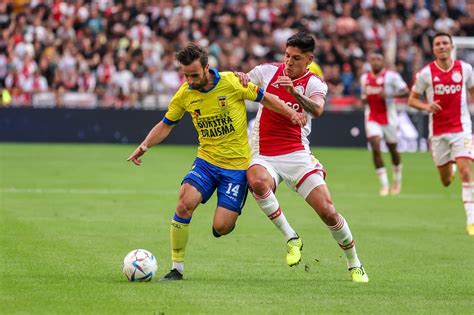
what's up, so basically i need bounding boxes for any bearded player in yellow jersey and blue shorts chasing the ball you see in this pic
[128,44,306,280]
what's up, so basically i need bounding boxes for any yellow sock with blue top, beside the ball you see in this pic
[170,213,191,274]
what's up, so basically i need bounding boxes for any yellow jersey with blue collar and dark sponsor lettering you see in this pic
[163,69,263,170]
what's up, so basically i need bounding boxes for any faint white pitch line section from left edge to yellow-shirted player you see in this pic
[0,187,178,195]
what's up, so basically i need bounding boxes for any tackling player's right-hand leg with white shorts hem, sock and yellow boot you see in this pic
[298,178,369,282]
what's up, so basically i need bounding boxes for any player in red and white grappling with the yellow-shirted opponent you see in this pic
[237,32,369,282]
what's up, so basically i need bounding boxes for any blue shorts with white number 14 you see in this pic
[181,158,248,214]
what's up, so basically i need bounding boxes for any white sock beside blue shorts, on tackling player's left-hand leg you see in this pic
[253,189,298,240]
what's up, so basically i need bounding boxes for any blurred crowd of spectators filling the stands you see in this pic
[0,0,474,107]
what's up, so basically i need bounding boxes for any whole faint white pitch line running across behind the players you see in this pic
[0,187,461,200]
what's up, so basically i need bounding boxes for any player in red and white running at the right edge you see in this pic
[408,33,474,236]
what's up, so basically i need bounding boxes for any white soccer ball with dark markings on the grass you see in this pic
[122,249,158,281]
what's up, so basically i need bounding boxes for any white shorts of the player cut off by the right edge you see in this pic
[430,132,474,166]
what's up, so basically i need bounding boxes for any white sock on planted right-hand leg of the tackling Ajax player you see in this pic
[328,215,362,268]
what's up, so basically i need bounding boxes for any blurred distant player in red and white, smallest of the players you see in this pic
[360,50,408,196]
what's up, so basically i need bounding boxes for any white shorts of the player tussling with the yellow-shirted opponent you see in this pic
[249,151,326,199]
